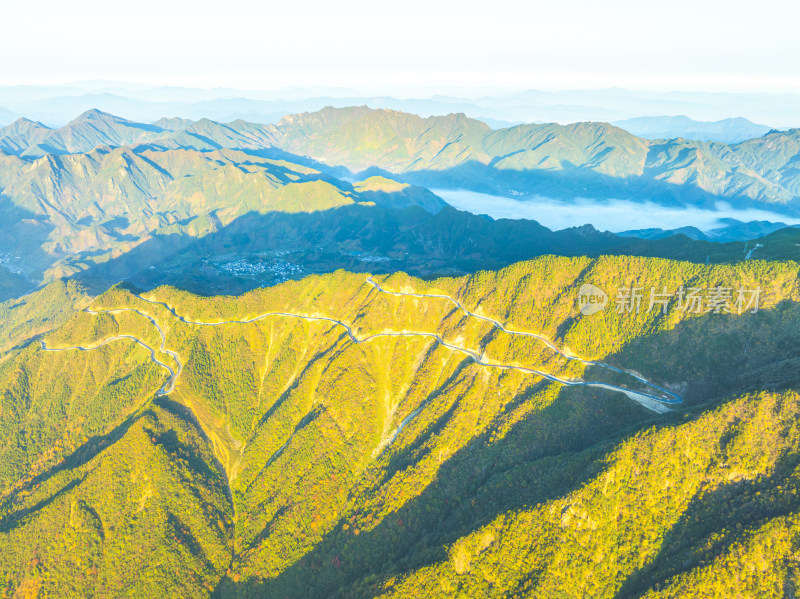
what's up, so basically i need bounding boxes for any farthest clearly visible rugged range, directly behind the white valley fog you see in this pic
[0,107,800,212]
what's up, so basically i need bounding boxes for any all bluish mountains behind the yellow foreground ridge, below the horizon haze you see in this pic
[0,108,800,304]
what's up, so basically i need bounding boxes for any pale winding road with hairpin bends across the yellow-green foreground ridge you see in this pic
[40,276,683,413]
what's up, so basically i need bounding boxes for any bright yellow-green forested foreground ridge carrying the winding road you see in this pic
[0,257,800,597]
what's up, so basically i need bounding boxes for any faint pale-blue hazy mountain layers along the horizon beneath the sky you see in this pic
[0,81,800,127]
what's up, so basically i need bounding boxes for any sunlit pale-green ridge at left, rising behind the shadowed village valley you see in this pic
[0,142,445,290]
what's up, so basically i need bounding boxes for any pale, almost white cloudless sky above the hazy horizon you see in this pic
[0,0,800,95]
